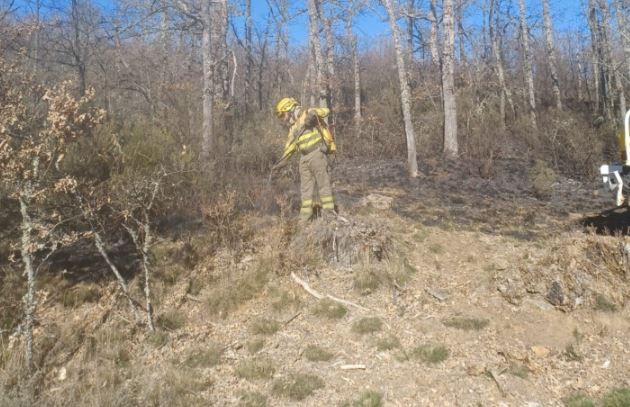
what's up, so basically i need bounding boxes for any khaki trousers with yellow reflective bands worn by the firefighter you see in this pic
[300,146,335,220]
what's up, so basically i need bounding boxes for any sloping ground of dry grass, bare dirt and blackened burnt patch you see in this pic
[0,159,630,406]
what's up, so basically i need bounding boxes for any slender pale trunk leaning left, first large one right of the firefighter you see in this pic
[383,0,418,177]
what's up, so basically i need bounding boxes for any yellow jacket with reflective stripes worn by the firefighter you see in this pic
[281,107,336,161]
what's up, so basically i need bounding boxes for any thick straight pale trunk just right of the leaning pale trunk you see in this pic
[442,0,458,158]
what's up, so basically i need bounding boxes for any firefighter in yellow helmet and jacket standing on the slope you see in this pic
[271,98,336,223]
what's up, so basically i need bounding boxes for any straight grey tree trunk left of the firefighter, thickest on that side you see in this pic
[201,0,214,161]
